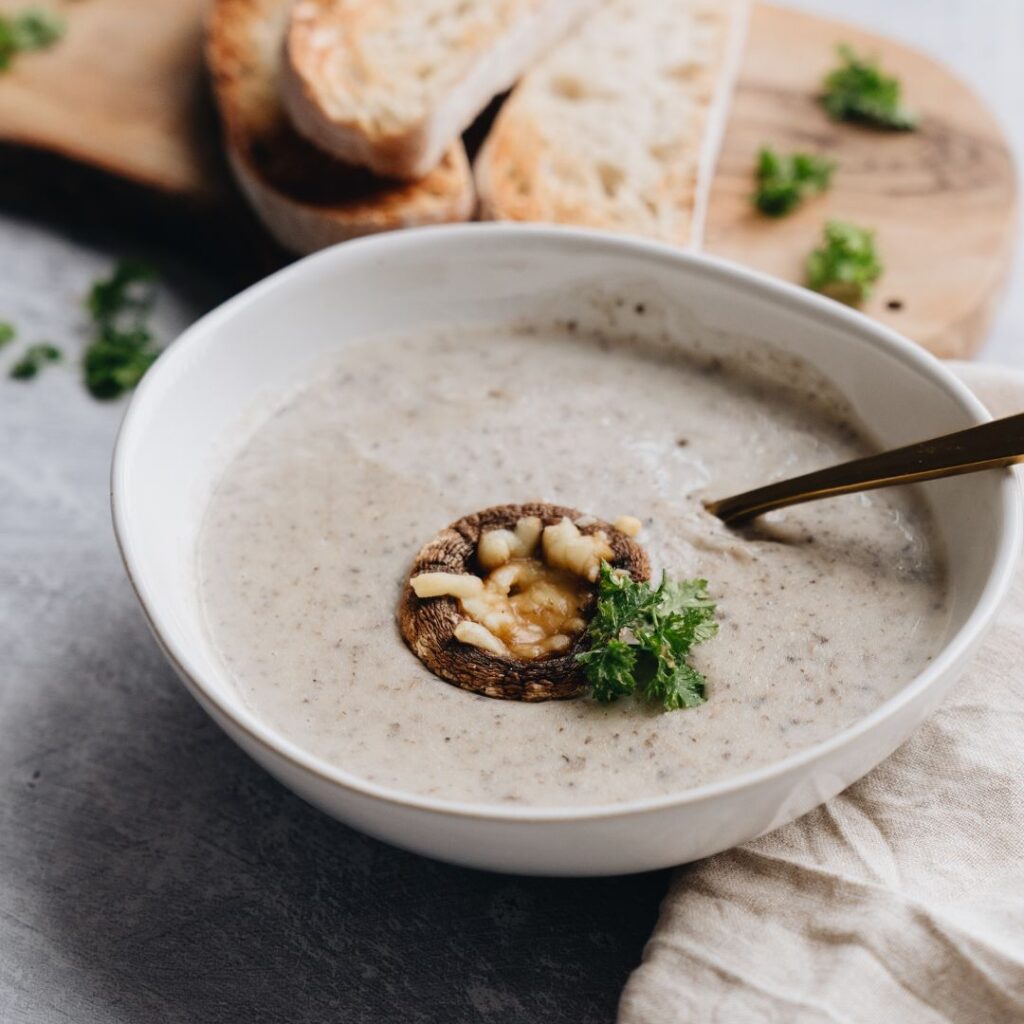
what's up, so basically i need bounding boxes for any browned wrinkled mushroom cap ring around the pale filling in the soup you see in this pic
[398,503,650,701]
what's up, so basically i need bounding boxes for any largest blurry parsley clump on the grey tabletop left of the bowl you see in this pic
[84,260,160,398]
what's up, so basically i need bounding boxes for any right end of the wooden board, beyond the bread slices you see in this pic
[705,5,1016,357]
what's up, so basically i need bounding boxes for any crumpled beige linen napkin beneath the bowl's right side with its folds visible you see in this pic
[618,364,1024,1024]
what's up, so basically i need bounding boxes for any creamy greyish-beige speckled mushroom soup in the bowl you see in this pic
[199,325,947,806]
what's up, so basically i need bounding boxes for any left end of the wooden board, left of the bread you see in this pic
[0,0,228,205]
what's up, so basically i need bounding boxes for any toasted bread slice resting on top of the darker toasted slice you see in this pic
[284,0,600,178]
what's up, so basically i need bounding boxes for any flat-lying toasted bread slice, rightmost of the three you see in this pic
[474,0,748,247]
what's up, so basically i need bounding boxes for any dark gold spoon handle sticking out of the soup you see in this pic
[705,413,1024,526]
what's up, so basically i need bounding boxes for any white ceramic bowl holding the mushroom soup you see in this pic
[113,225,1021,874]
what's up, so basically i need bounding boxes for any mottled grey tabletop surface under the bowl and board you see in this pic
[0,0,1024,1024]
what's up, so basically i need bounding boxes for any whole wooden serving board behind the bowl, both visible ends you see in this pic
[0,0,1016,357]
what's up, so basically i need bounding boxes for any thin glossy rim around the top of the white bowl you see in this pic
[111,223,1022,823]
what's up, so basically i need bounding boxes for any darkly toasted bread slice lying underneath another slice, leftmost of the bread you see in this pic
[207,0,475,253]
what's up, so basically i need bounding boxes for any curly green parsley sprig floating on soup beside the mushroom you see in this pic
[577,562,718,711]
